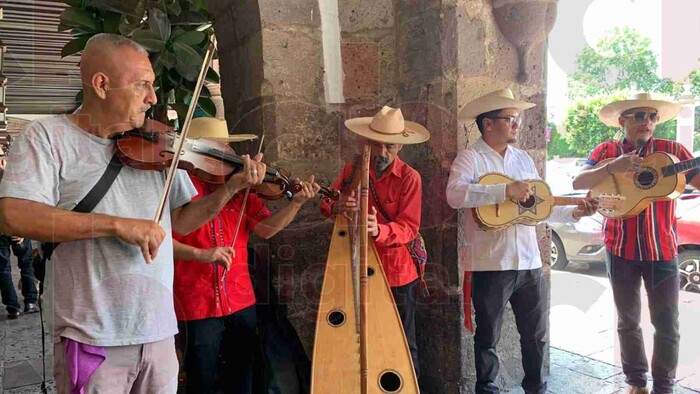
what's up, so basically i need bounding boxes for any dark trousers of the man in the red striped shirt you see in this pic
[606,253,680,394]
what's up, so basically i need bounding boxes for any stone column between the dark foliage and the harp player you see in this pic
[209,0,343,357]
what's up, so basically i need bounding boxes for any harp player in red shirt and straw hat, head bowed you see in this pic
[321,107,430,376]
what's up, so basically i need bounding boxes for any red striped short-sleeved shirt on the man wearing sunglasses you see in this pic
[586,138,698,261]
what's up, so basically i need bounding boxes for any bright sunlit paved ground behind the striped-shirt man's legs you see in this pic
[550,263,700,392]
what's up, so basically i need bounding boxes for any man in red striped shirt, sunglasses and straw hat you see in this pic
[574,93,700,394]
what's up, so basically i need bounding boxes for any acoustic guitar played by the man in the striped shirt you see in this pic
[591,152,700,219]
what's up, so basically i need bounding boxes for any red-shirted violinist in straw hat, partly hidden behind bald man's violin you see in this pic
[173,118,319,394]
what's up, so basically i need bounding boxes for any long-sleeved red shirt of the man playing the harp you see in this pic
[321,157,422,287]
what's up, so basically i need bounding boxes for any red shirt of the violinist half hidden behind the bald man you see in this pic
[173,177,270,321]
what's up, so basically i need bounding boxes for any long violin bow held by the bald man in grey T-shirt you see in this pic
[154,34,216,223]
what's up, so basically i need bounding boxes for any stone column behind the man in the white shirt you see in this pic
[396,0,549,393]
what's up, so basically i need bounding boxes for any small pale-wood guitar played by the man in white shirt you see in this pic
[472,172,624,231]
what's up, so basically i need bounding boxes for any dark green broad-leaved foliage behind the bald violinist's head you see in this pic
[58,0,219,124]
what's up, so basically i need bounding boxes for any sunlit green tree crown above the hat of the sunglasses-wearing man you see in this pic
[568,27,682,100]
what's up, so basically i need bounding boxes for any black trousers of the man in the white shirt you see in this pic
[472,268,549,394]
